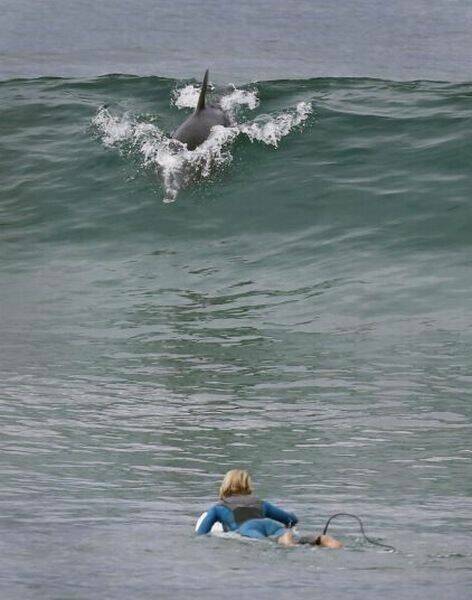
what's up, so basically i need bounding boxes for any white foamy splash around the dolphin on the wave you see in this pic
[92,84,312,202]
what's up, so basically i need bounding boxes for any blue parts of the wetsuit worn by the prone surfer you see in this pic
[197,499,298,539]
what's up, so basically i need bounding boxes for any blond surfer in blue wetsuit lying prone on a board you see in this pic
[196,469,343,548]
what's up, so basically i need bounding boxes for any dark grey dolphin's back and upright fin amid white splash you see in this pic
[172,69,231,150]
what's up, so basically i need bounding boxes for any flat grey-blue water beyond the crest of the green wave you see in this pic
[0,0,472,83]
